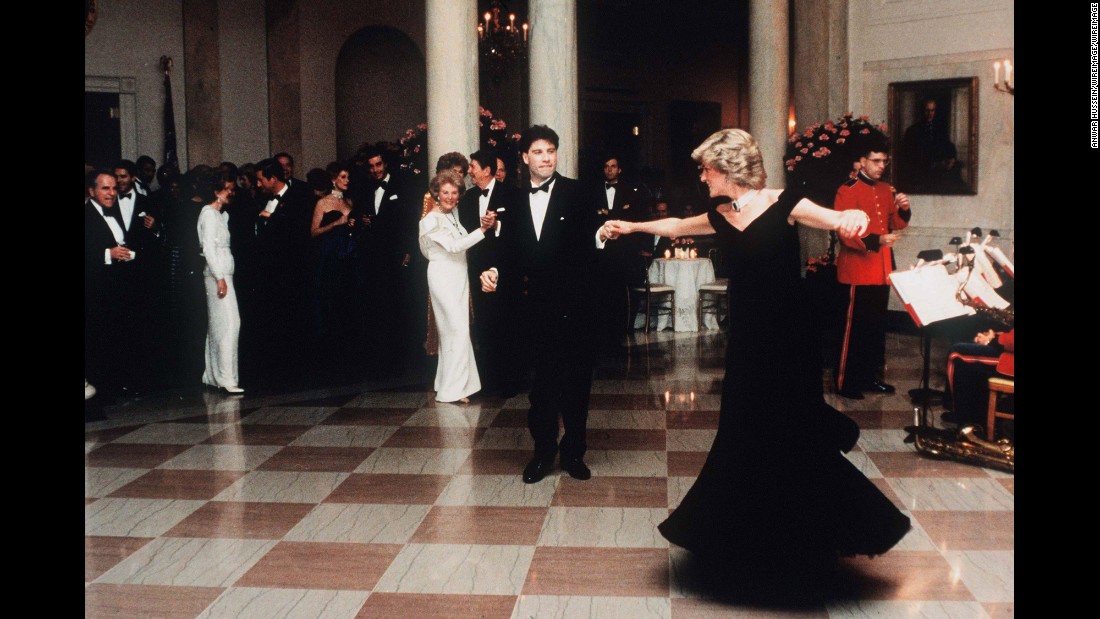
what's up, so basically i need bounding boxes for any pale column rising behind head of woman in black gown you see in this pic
[749,0,790,187]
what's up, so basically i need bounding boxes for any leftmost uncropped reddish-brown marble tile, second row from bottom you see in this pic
[235,542,402,590]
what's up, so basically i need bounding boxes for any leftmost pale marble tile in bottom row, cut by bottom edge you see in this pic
[198,587,370,619]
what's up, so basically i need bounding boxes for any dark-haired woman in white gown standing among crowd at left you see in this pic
[196,174,244,394]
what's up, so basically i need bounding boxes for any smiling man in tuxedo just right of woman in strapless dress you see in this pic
[354,148,418,373]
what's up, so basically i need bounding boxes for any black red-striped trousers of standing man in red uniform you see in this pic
[836,285,890,389]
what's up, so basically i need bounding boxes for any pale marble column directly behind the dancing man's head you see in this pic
[528,0,581,178]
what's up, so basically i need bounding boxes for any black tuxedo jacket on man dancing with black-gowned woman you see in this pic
[496,175,602,318]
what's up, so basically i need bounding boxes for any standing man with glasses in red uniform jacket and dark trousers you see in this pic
[834,136,912,400]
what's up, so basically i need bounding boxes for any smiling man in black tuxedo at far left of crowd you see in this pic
[84,169,149,396]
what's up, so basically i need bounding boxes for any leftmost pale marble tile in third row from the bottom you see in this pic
[84,498,206,538]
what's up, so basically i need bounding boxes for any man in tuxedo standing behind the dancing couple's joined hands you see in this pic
[596,155,647,350]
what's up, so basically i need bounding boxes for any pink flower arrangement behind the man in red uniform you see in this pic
[783,112,888,207]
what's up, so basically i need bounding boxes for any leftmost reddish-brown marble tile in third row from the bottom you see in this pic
[164,500,314,540]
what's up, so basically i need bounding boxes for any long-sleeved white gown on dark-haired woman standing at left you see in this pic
[198,205,241,387]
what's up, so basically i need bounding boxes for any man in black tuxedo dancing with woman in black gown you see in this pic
[481,125,608,484]
